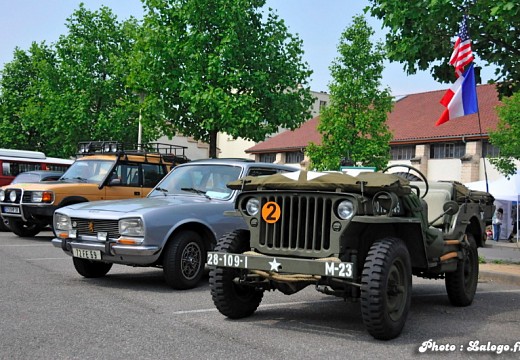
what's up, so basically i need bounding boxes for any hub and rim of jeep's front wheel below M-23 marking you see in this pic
[386,261,408,321]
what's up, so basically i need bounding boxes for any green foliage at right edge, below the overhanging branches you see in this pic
[489,92,520,177]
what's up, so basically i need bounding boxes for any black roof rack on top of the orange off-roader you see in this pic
[77,141,188,163]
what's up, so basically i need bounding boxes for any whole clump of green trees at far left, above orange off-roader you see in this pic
[0,5,139,157]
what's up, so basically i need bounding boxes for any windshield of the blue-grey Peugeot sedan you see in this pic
[148,164,241,200]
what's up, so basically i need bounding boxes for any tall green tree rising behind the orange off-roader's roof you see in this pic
[50,4,139,153]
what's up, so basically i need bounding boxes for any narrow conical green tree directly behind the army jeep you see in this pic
[306,16,392,170]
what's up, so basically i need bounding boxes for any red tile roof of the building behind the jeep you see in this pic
[246,84,500,153]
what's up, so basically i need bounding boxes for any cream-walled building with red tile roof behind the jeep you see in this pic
[246,84,510,183]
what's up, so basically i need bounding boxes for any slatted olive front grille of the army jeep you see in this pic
[258,194,332,256]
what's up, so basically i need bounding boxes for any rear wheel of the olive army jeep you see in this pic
[445,234,479,306]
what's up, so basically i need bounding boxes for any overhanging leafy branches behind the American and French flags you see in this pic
[366,0,520,96]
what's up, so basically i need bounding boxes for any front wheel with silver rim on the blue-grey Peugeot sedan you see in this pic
[163,231,206,290]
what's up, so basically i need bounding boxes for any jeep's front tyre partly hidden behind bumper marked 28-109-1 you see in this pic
[209,230,264,319]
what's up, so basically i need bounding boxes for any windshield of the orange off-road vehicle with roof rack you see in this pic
[60,160,115,184]
